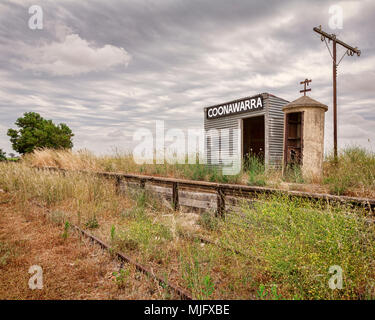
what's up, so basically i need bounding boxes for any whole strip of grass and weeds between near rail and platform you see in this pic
[0,158,375,300]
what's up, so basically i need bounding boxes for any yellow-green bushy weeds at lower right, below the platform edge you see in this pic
[231,196,375,299]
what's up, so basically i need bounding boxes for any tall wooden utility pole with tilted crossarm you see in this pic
[313,26,361,160]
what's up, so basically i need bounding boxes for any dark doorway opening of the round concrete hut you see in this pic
[284,112,303,166]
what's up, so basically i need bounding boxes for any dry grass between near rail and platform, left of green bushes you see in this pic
[0,163,260,299]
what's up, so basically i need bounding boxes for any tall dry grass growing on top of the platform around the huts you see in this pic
[23,147,375,197]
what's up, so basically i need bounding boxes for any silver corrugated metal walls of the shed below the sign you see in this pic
[204,93,288,170]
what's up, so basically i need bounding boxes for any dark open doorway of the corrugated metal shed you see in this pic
[242,116,265,161]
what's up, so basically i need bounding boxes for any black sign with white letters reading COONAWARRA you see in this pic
[206,96,263,119]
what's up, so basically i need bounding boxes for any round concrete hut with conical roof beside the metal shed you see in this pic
[283,96,328,180]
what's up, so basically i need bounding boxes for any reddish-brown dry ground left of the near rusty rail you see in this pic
[0,192,173,299]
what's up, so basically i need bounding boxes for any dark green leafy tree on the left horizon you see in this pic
[8,112,74,154]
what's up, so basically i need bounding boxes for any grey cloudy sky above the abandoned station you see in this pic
[0,0,375,154]
